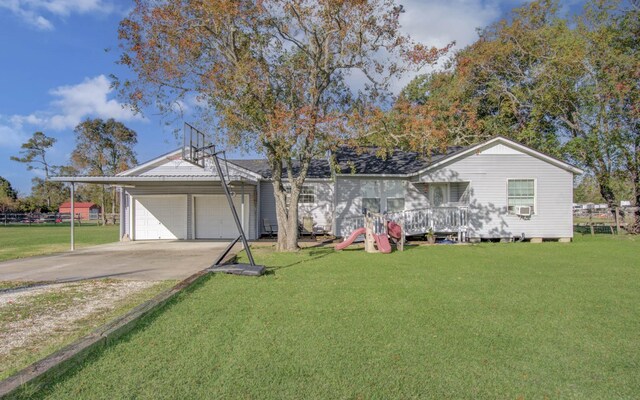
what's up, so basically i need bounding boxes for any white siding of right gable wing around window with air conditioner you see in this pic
[419,149,573,238]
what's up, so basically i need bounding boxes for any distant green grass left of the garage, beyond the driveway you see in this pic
[0,224,119,261]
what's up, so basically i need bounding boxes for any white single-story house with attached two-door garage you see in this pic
[55,137,582,240]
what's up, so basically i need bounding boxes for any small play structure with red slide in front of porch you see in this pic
[336,212,404,253]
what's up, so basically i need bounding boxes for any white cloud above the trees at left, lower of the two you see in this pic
[0,75,143,138]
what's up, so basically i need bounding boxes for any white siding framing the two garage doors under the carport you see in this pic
[123,182,258,239]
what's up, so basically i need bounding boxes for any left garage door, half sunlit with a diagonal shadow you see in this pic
[134,196,187,240]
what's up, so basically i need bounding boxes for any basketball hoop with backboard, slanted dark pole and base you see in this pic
[182,122,266,276]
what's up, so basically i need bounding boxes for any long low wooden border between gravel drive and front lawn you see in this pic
[0,253,237,399]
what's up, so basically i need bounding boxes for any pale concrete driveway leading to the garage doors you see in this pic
[0,241,236,281]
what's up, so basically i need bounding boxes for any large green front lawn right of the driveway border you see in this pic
[26,237,640,399]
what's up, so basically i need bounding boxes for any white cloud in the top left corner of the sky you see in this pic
[0,0,116,31]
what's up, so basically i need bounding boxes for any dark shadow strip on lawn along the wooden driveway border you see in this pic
[11,273,215,399]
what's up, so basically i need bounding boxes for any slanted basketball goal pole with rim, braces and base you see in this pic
[183,130,266,276]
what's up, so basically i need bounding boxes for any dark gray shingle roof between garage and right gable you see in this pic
[229,146,466,179]
